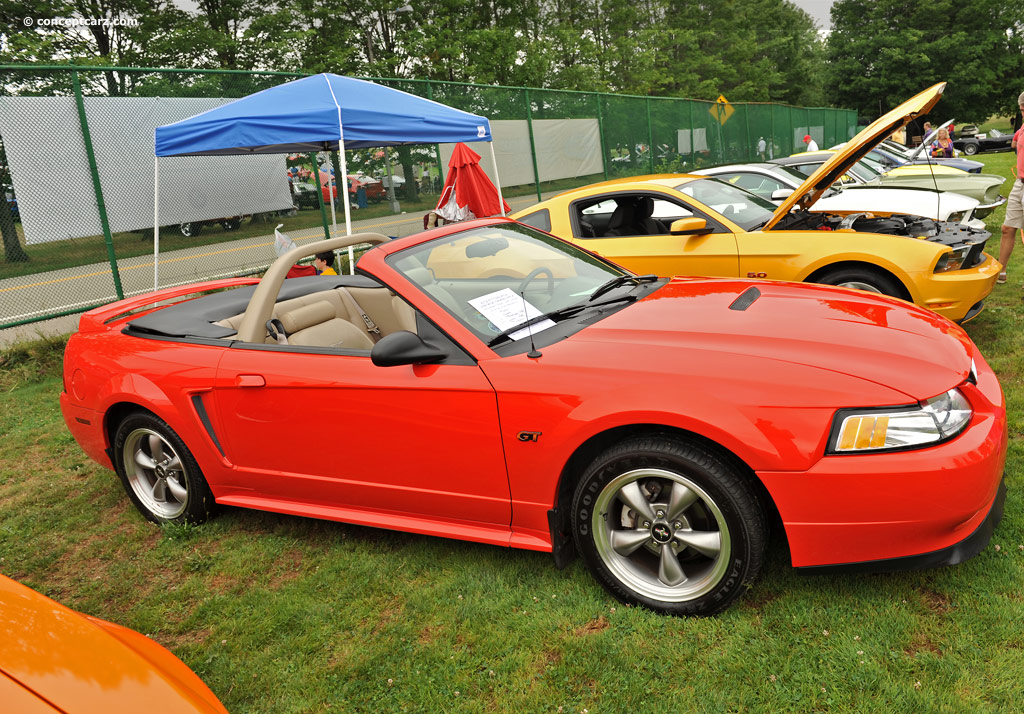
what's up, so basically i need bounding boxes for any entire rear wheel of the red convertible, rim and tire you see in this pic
[114,412,216,524]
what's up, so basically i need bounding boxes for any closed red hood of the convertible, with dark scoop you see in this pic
[574,278,974,406]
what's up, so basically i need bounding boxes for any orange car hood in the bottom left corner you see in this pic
[0,576,226,714]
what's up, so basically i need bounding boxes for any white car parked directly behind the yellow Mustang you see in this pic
[690,164,985,230]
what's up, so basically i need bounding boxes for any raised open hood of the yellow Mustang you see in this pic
[763,82,946,230]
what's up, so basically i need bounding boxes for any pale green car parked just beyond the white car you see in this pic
[771,152,1007,218]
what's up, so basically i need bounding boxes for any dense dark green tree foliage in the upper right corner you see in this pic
[826,0,1024,121]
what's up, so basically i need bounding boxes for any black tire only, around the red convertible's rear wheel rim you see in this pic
[113,412,215,524]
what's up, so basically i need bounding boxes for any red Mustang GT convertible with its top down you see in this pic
[60,219,1007,615]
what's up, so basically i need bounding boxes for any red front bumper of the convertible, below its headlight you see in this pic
[758,362,1008,568]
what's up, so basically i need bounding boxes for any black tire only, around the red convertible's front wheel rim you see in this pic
[571,437,767,616]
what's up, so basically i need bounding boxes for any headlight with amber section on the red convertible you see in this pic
[828,389,973,454]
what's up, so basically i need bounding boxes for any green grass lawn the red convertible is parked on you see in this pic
[0,154,1024,714]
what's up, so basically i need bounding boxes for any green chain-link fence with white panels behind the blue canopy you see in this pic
[0,66,856,328]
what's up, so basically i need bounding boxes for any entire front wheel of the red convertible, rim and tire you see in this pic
[572,435,767,616]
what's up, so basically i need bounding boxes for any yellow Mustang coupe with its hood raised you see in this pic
[512,83,1001,322]
